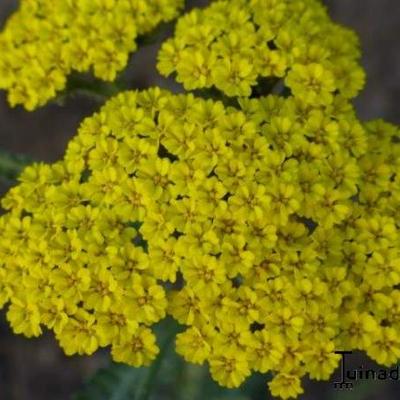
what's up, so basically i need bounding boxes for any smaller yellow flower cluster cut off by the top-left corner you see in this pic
[0,0,183,110]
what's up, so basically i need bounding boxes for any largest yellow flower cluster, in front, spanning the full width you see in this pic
[0,89,400,398]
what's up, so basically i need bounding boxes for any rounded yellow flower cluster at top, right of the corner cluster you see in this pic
[158,0,364,104]
